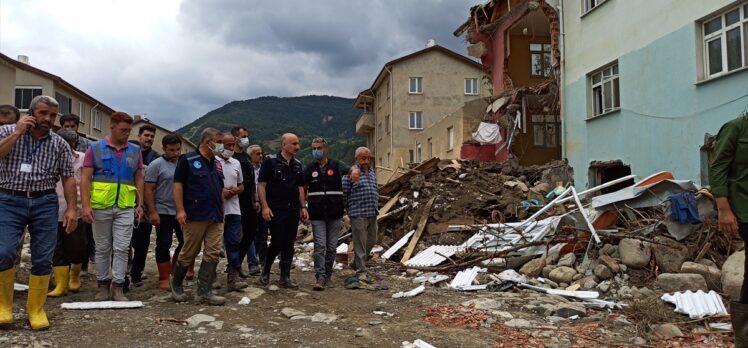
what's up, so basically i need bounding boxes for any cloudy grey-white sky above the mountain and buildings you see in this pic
[0,0,483,129]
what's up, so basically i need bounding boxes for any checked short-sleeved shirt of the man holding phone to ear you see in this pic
[0,124,74,191]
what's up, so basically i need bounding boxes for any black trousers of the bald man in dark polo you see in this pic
[265,209,299,265]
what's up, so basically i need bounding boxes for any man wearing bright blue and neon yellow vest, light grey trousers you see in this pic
[80,112,144,301]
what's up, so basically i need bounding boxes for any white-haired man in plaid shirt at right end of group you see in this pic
[343,147,379,279]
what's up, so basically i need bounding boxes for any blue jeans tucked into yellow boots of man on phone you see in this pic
[0,192,58,276]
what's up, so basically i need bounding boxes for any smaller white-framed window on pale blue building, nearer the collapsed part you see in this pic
[587,60,621,119]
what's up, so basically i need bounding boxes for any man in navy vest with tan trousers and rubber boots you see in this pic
[171,128,226,305]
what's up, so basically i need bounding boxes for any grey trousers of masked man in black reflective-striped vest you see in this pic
[312,219,342,279]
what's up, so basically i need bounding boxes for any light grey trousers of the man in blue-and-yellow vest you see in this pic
[91,205,135,284]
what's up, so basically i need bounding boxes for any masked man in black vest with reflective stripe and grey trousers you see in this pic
[304,138,350,291]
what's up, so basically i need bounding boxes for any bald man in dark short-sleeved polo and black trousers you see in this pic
[257,133,308,289]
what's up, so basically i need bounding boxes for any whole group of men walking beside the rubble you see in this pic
[0,96,379,330]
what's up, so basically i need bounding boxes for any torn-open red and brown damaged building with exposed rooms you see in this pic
[454,0,561,165]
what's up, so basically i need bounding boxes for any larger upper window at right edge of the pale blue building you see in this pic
[699,3,748,80]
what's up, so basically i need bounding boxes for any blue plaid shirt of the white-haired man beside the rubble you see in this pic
[343,169,379,218]
